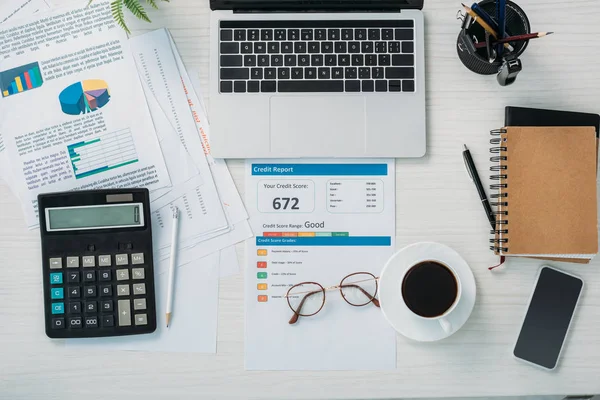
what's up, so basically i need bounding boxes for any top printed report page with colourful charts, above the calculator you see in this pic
[0,1,171,226]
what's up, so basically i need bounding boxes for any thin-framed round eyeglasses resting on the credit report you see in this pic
[285,272,379,325]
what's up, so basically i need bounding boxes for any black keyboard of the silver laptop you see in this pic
[219,20,415,93]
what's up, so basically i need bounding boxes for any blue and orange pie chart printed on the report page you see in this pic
[58,79,110,115]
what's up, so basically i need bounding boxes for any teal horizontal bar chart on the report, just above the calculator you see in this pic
[67,128,138,179]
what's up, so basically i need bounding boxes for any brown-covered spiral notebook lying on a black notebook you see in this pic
[491,127,598,263]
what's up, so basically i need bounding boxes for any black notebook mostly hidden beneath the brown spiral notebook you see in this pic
[504,107,600,138]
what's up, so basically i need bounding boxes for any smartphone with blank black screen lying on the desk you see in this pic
[513,266,583,370]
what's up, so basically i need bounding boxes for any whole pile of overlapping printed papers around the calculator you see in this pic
[0,0,252,352]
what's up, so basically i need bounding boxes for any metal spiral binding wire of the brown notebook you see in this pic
[490,129,508,253]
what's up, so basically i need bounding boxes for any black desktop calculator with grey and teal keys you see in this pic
[38,189,156,338]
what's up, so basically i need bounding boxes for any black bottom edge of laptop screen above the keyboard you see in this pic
[210,0,424,11]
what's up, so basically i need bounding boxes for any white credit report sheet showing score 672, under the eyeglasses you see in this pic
[245,159,396,370]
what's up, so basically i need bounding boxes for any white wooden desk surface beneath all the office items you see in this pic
[0,0,600,400]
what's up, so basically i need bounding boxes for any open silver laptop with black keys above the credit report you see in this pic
[210,0,426,158]
